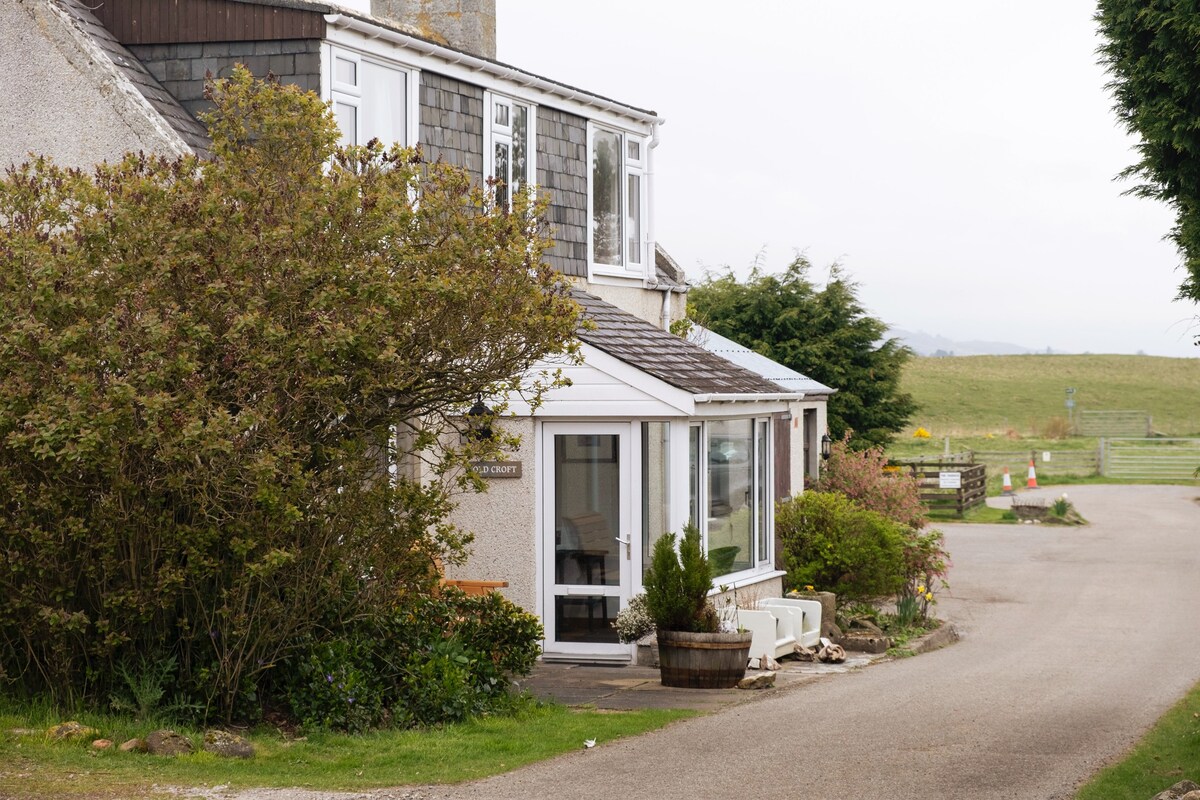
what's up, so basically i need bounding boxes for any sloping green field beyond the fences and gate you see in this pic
[896,355,1200,438]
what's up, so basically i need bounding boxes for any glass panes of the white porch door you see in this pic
[554,434,628,643]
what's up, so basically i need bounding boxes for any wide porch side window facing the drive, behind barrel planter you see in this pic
[689,419,772,577]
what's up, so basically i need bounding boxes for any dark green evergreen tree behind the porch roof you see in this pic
[689,255,917,447]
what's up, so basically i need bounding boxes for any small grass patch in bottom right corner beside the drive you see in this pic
[1075,684,1200,800]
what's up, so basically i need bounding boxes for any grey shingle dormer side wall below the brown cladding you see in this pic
[128,38,320,114]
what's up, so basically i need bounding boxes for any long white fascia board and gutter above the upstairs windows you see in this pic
[325,13,666,136]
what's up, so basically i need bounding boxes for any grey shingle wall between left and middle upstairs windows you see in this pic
[420,71,484,180]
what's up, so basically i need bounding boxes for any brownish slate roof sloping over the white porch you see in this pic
[571,289,784,395]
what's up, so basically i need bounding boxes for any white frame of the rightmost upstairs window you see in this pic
[586,120,650,277]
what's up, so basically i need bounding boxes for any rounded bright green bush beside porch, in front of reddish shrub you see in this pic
[775,492,906,603]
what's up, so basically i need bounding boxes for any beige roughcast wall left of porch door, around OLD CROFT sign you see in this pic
[446,419,538,612]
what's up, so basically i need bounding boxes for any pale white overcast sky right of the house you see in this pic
[497,0,1200,356]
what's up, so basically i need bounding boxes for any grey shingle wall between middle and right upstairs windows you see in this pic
[536,107,588,277]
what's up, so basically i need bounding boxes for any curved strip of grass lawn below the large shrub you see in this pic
[0,702,696,800]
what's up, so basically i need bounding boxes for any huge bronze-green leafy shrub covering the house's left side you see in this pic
[0,70,577,720]
